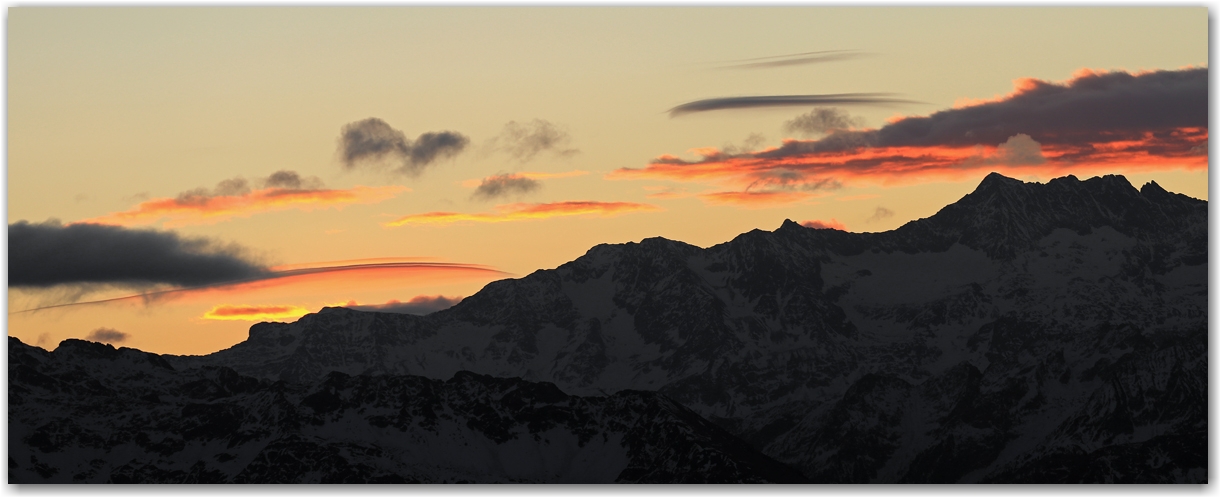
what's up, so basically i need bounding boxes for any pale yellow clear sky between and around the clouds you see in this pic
[7,7,1208,353]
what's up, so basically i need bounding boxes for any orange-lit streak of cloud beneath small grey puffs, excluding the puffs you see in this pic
[77,186,410,226]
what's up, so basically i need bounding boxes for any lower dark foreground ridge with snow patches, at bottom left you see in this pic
[9,338,805,484]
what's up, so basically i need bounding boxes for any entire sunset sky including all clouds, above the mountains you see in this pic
[6,6,1209,354]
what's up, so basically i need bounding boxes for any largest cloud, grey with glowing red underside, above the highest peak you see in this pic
[606,67,1208,186]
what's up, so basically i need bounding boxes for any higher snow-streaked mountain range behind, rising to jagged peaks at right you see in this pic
[167,175,1208,481]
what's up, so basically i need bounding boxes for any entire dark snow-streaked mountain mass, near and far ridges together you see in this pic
[10,173,1208,482]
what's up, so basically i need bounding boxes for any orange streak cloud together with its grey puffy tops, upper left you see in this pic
[77,171,410,226]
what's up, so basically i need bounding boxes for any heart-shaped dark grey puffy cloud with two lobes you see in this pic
[339,117,470,176]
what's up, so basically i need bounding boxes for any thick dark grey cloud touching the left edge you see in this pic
[9,220,266,288]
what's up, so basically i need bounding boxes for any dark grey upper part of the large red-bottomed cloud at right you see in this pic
[758,67,1208,160]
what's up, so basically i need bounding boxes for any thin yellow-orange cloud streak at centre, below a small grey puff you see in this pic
[384,200,660,227]
